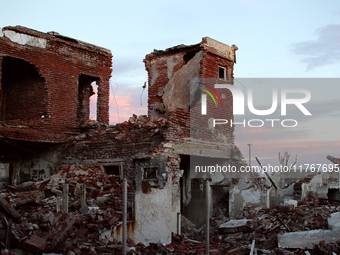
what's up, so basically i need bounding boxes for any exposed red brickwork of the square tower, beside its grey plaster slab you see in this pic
[144,48,234,144]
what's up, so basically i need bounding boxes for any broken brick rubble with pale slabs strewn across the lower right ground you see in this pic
[130,195,340,255]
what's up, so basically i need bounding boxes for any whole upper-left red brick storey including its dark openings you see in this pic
[0,26,112,140]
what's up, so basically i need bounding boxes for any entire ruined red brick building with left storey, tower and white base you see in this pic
[0,26,247,243]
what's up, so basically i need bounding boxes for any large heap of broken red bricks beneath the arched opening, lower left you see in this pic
[0,165,133,254]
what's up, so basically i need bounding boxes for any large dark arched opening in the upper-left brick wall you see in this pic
[0,56,47,121]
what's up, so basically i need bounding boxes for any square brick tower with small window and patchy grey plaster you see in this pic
[144,37,237,145]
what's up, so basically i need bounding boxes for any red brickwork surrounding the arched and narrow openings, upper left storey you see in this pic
[0,28,112,140]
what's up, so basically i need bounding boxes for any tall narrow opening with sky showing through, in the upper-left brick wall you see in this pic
[77,74,98,125]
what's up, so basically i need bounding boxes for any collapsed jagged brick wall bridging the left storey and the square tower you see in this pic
[63,112,190,160]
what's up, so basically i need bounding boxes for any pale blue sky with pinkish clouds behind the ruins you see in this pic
[0,0,340,169]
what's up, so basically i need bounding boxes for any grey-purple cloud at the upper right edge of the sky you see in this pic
[292,24,340,70]
